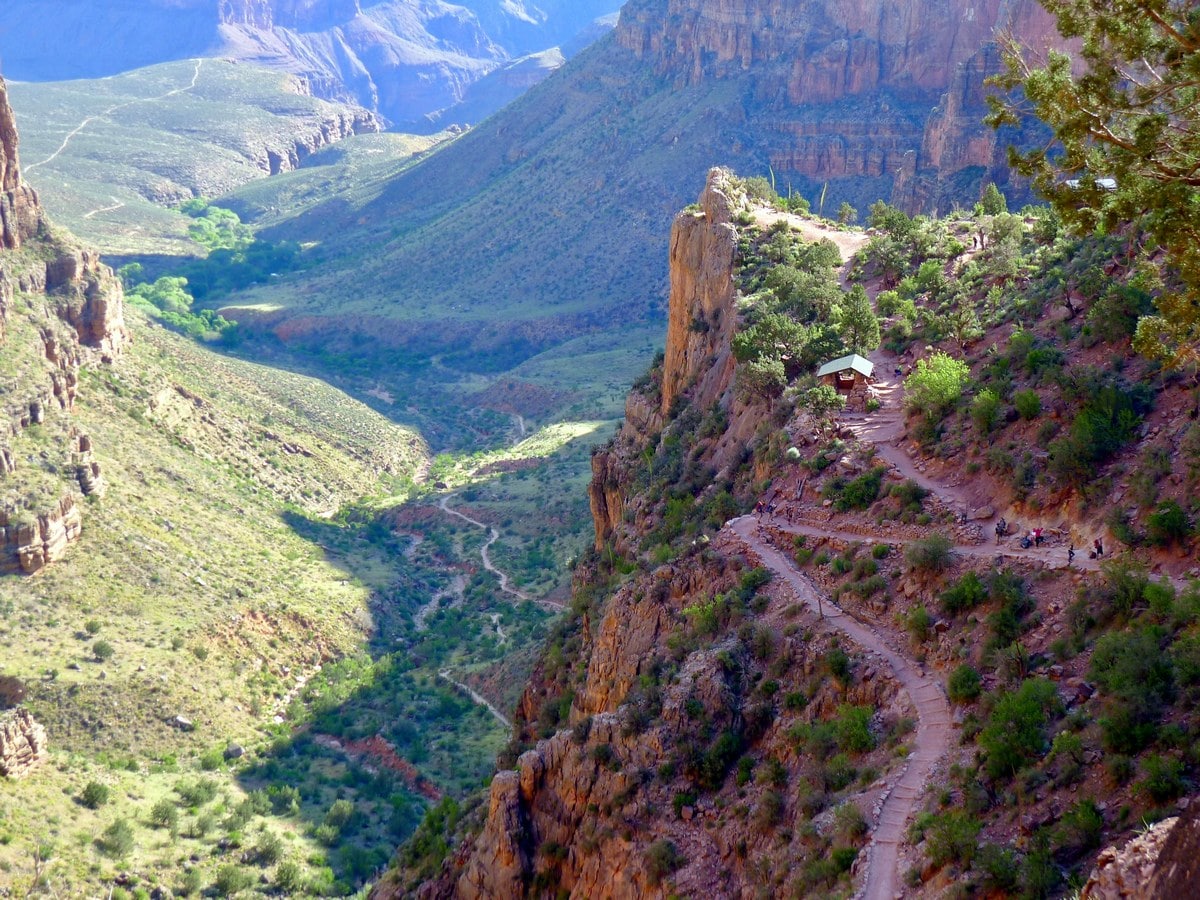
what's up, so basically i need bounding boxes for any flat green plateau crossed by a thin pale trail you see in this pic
[10,60,374,254]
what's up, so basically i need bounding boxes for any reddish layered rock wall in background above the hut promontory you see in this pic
[617,0,1062,211]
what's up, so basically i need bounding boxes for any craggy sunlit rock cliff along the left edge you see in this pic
[0,79,130,574]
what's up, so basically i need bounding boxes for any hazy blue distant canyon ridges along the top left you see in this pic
[0,0,618,130]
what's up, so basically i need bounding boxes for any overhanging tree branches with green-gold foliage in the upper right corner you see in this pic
[989,0,1200,367]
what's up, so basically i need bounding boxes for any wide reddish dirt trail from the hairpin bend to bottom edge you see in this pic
[726,516,952,900]
